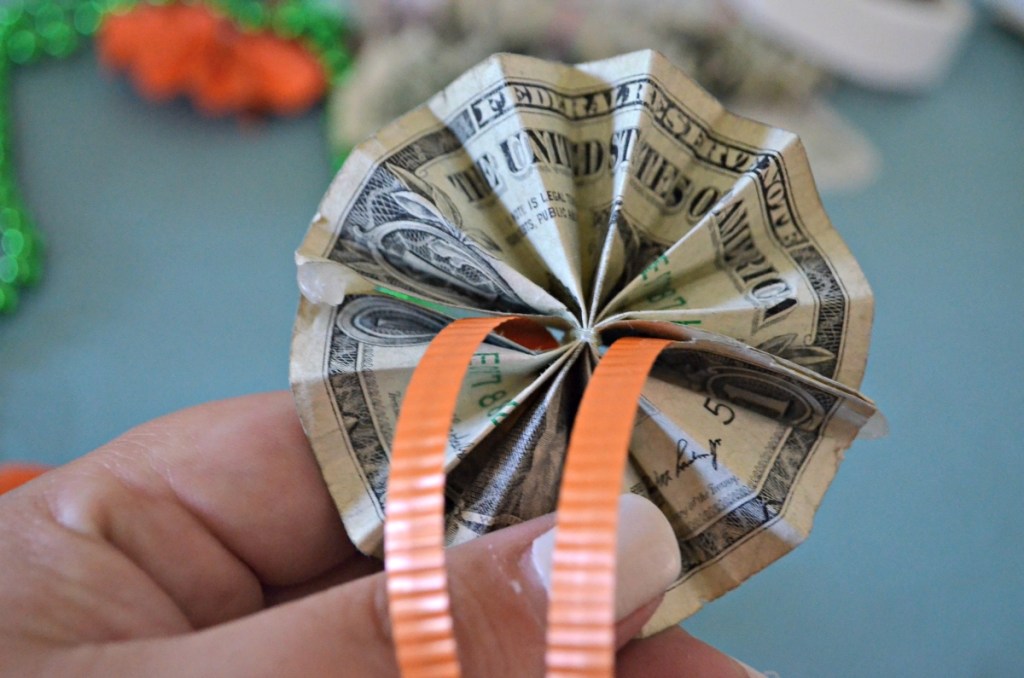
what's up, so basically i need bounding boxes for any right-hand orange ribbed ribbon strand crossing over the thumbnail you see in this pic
[546,337,672,678]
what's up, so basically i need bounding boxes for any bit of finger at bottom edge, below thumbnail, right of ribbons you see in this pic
[615,627,764,678]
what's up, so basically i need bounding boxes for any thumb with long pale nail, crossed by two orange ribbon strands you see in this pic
[90,495,680,678]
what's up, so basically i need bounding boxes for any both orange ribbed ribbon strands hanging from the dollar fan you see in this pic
[384,317,671,678]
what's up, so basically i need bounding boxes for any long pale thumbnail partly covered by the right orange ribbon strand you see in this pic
[532,495,680,620]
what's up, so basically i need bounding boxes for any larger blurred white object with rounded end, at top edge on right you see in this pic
[731,0,970,90]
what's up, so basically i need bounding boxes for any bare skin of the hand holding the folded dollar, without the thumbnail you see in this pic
[0,392,758,678]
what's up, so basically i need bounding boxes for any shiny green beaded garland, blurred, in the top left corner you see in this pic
[0,0,351,313]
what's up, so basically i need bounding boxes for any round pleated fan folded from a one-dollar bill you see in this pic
[291,51,876,675]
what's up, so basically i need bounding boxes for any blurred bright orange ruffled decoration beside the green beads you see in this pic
[97,3,327,116]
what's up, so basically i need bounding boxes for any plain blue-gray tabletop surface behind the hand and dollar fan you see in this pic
[0,11,1024,678]
